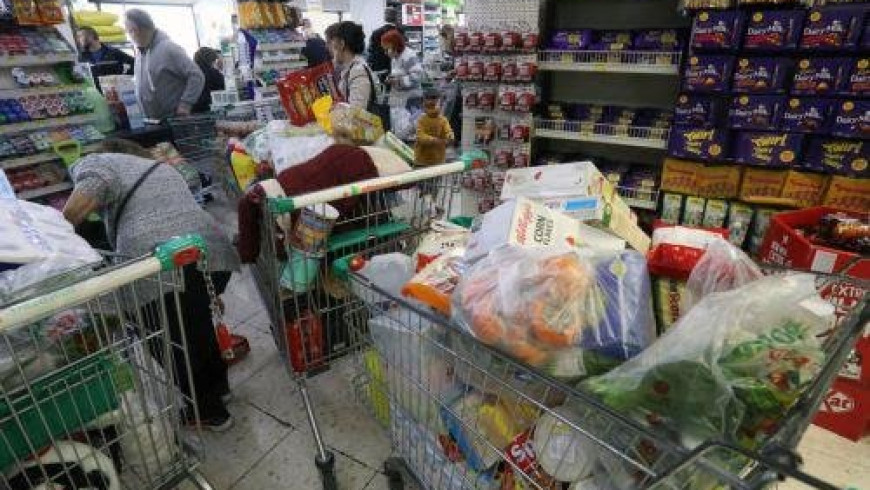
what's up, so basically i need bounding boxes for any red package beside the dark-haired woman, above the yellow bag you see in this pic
[278,63,341,126]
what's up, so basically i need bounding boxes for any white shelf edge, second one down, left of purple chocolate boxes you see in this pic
[535,119,670,150]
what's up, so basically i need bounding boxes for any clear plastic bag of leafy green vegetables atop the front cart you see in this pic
[580,274,834,458]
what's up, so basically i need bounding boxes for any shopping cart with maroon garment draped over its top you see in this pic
[253,157,478,489]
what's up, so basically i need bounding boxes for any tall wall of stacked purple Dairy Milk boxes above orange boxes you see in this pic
[662,2,870,252]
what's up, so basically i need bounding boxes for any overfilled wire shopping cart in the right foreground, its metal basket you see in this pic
[351,264,868,490]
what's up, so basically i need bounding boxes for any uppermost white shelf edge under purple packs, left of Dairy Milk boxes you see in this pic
[538,51,680,75]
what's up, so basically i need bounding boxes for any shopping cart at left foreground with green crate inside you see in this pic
[0,236,218,490]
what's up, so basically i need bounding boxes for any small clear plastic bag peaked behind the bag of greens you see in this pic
[682,238,763,311]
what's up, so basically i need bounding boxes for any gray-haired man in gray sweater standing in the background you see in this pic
[124,9,205,120]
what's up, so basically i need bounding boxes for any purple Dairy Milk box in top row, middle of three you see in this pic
[743,10,806,51]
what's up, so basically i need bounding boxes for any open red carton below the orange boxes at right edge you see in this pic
[759,207,870,279]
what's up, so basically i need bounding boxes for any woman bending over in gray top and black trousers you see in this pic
[63,140,239,431]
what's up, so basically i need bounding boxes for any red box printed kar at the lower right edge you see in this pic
[813,379,870,441]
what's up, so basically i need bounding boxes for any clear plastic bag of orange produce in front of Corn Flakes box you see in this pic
[453,246,655,379]
